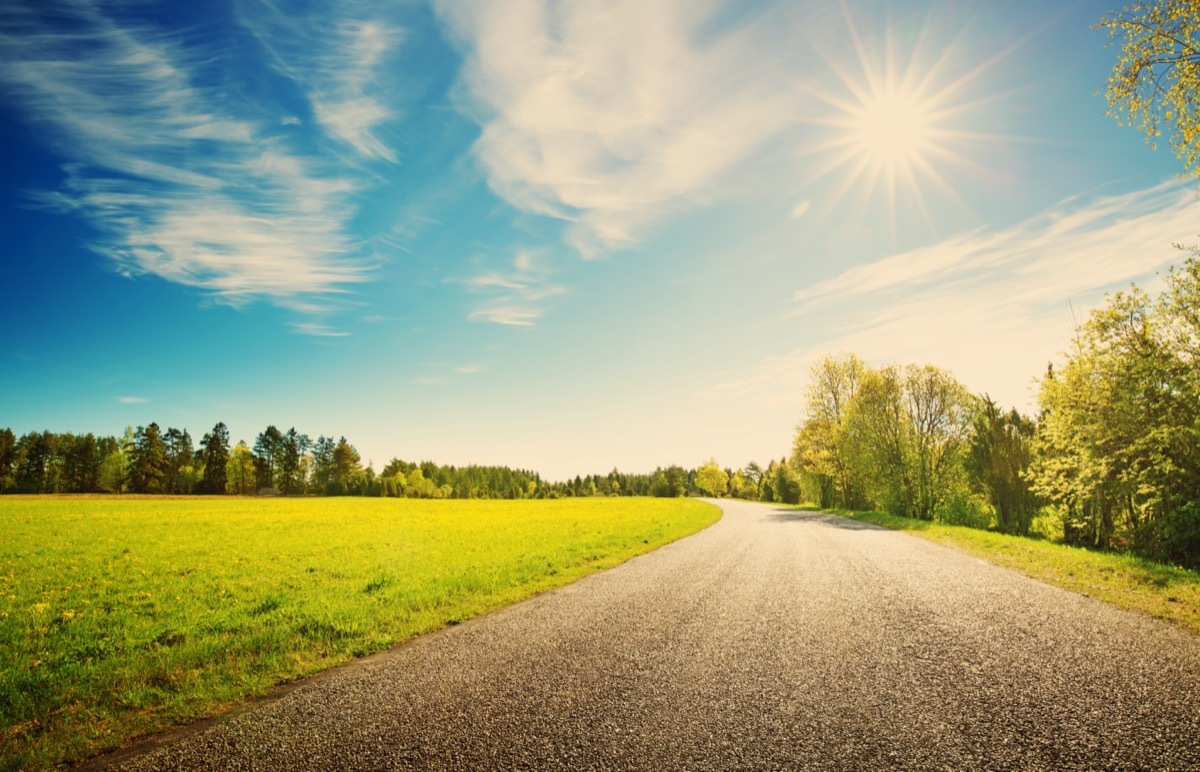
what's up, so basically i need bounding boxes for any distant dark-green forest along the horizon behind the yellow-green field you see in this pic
[0,423,800,503]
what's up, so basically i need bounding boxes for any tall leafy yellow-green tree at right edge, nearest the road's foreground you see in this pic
[1031,276,1200,565]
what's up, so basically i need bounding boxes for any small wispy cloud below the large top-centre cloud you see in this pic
[463,251,566,327]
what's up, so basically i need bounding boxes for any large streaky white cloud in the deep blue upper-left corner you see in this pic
[0,0,372,310]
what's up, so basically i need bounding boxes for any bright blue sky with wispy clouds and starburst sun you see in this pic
[0,0,1200,480]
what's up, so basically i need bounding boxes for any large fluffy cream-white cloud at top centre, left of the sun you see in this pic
[437,0,798,256]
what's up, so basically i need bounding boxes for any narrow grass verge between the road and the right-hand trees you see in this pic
[802,505,1200,635]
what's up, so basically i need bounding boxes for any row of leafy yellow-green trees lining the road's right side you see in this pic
[790,251,1200,567]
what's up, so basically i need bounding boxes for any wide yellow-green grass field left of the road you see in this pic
[0,496,720,767]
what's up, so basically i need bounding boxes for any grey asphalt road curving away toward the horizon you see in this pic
[107,502,1200,770]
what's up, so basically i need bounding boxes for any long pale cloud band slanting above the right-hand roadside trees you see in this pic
[700,182,1200,412]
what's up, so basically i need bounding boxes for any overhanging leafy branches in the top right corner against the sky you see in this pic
[1098,0,1200,175]
